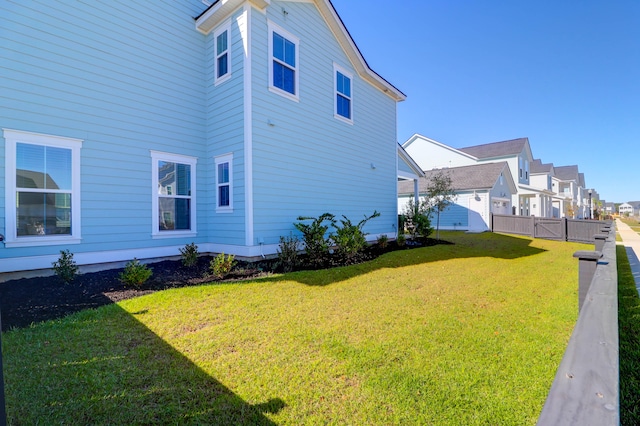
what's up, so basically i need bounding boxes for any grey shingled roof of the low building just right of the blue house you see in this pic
[398,161,515,195]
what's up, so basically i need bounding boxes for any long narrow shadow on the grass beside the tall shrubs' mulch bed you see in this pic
[260,232,546,286]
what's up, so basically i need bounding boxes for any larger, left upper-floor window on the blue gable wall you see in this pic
[269,23,300,100]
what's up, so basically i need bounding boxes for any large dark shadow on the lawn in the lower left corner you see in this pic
[3,305,285,425]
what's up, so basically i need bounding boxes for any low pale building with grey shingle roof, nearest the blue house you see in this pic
[398,161,516,231]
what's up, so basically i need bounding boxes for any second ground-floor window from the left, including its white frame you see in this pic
[151,151,197,238]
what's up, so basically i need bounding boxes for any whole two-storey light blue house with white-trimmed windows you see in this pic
[0,0,405,272]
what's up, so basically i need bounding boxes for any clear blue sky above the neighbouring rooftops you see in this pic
[332,0,640,202]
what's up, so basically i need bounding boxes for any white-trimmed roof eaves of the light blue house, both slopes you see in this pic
[195,0,407,102]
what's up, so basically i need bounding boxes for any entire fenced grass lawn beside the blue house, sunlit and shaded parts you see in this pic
[3,232,593,425]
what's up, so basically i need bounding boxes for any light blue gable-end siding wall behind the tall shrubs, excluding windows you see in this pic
[251,1,397,246]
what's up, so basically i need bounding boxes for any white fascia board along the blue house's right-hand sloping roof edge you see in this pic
[315,0,407,102]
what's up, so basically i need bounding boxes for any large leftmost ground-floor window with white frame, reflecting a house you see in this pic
[3,129,82,247]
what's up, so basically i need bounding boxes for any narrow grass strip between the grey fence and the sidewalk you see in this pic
[616,246,640,425]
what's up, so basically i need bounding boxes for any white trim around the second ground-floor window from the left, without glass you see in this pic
[150,150,198,239]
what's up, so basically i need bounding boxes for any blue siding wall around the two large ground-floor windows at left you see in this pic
[0,0,209,270]
